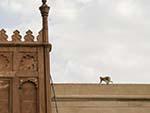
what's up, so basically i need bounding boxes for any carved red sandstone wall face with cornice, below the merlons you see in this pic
[0,42,51,113]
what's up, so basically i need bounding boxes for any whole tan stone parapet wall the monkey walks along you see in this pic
[52,84,150,113]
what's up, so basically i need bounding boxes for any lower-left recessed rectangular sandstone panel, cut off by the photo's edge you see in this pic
[0,79,11,113]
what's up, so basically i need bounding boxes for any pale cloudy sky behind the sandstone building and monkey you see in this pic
[0,0,150,83]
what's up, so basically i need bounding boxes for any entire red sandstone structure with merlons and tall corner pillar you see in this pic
[0,0,52,113]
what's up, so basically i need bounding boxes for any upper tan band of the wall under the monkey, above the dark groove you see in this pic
[54,84,150,97]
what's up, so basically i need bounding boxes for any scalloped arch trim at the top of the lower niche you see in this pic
[19,78,38,89]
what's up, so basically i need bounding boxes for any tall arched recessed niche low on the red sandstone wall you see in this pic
[19,80,38,113]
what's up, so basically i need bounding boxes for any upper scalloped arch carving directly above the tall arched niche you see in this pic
[19,54,37,71]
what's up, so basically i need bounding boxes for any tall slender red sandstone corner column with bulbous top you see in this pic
[40,0,52,113]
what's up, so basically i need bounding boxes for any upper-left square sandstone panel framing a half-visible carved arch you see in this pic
[0,52,12,72]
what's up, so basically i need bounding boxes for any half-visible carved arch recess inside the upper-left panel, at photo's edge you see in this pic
[0,54,10,71]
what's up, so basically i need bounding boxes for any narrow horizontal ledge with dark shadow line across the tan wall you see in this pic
[52,95,150,101]
